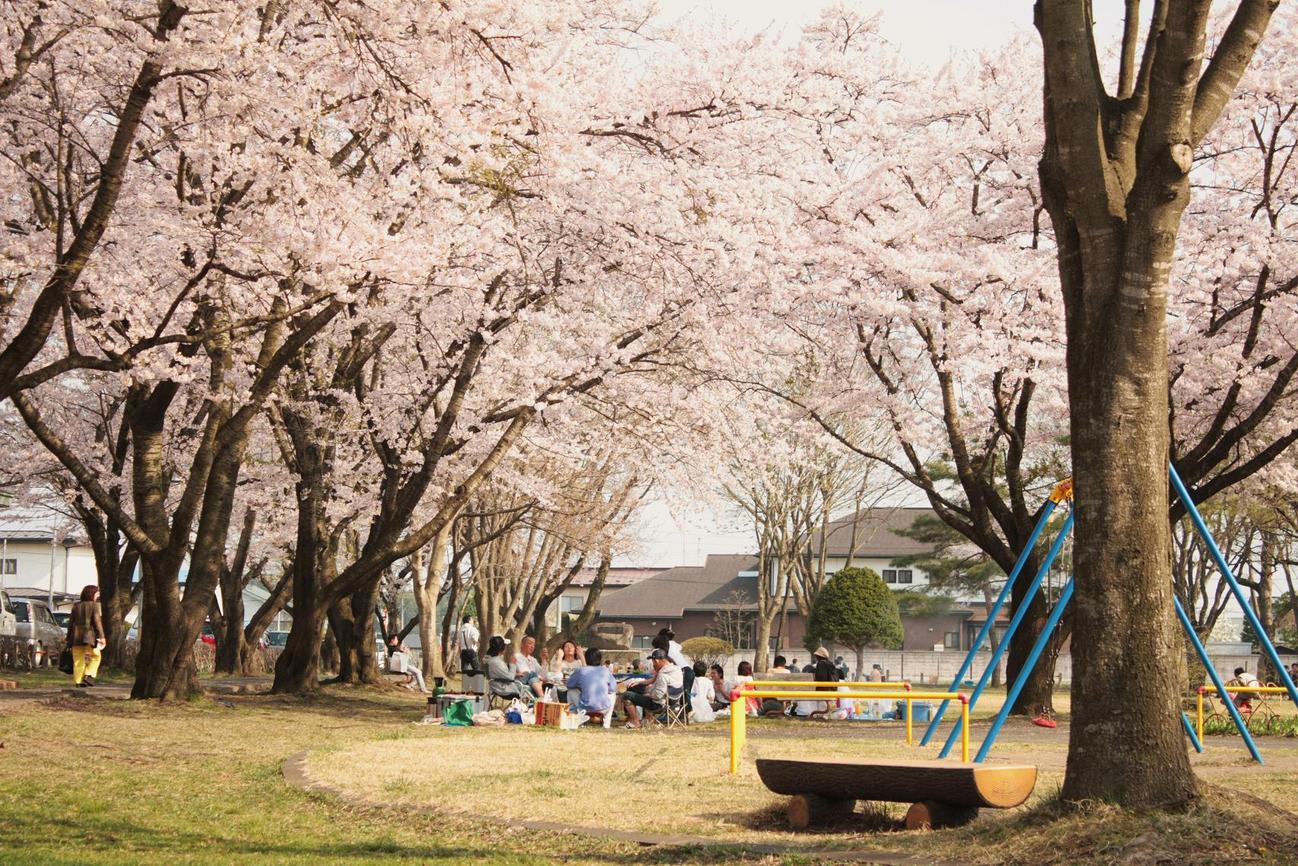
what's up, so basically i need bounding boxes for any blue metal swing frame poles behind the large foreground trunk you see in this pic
[920,466,1298,763]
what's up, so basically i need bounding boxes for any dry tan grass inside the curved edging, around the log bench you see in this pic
[310,721,1298,863]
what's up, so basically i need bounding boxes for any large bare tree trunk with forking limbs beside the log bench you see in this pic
[1036,0,1277,809]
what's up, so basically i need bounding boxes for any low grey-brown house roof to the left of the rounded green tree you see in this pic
[600,553,757,619]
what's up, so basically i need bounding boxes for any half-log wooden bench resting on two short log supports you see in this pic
[757,758,1037,830]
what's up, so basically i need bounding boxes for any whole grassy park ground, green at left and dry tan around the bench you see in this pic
[0,683,1298,866]
